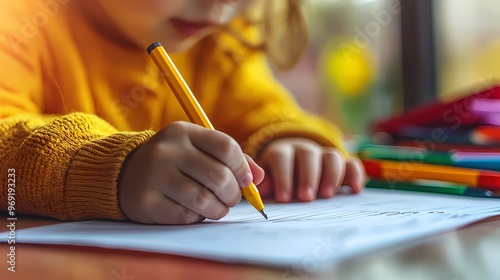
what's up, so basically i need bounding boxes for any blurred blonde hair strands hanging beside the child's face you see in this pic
[224,0,308,70]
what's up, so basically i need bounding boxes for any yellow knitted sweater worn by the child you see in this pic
[0,0,341,220]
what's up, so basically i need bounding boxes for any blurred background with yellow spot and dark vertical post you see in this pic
[276,0,500,136]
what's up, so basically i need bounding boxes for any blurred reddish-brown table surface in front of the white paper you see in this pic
[0,214,500,280]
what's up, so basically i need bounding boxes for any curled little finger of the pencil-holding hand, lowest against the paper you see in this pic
[146,192,205,225]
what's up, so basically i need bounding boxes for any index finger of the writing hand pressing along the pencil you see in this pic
[190,127,253,188]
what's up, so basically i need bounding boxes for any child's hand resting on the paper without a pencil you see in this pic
[257,138,365,202]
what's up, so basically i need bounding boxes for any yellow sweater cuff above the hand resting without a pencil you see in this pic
[242,122,349,158]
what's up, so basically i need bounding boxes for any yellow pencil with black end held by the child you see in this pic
[148,42,267,219]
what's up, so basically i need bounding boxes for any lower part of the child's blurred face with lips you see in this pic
[90,0,254,52]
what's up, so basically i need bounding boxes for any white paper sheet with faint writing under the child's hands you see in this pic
[7,190,500,270]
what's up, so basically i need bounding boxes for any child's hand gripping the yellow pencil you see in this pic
[118,122,264,224]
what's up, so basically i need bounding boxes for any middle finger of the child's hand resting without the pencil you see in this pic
[295,146,322,201]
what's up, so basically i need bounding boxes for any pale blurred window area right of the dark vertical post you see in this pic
[434,0,500,97]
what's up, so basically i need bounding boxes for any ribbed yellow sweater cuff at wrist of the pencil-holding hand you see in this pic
[64,131,155,220]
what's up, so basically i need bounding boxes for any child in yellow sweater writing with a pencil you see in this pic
[0,0,364,224]
